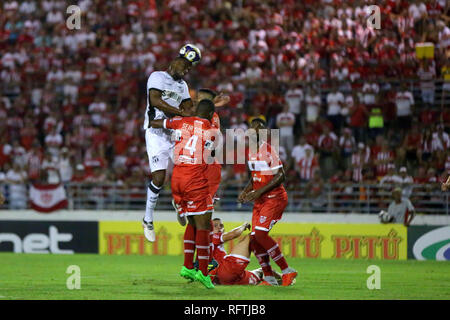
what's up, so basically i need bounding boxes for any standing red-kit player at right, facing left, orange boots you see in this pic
[238,118,297,286]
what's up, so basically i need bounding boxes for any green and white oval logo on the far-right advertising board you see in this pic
[413,226,450,260]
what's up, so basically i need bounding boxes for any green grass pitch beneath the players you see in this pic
[0,253,450,300]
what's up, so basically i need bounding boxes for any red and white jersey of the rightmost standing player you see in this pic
[248,142,286,199]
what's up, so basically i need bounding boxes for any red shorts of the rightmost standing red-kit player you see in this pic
[252,192,288,233]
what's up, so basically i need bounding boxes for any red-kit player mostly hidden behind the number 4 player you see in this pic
[172,88,230,226]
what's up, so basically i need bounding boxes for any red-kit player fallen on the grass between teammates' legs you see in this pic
[209,218,282,285]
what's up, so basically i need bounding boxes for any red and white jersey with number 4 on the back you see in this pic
[164,117,212,167]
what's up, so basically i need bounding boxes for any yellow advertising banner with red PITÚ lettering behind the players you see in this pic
[99,221,407,260]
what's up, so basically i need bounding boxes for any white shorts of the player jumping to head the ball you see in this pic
[145,128,175,172]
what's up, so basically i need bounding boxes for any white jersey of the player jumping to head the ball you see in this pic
[144,71,191,135]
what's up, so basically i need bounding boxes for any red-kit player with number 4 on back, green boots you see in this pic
[151,100,214,288]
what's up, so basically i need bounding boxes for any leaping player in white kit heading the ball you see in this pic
[142,44,201,242]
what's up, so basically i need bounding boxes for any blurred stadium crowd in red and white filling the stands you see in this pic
[0,0,450,211]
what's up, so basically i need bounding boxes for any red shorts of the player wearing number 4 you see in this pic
[172,166,214,216]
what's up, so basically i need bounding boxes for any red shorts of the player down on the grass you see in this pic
[211,254,261,285]
